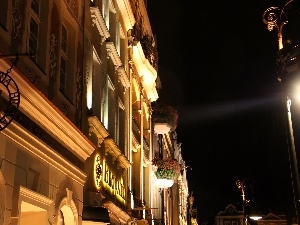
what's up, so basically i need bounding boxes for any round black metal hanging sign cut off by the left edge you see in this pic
[0,71,20,131]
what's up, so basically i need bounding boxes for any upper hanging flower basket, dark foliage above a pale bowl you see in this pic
[152,103,178,134]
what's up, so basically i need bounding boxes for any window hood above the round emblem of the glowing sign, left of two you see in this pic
[88,116,109,146]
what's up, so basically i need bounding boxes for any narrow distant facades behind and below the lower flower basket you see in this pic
[151,131,189,225]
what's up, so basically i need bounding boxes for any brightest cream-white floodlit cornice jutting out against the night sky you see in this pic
[132,43,158,102]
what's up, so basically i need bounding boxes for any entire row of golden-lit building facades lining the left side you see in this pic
[0,0,188,225]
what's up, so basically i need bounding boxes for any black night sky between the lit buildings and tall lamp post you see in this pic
[147,0,300,224]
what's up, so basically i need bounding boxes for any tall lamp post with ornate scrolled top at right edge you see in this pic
[262,0,300,223]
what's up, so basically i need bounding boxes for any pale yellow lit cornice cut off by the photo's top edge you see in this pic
[116,0,135,31]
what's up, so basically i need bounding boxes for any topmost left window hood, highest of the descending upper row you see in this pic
[90,6,110,44]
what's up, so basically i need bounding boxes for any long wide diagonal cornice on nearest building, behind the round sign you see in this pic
[0,60,95,161]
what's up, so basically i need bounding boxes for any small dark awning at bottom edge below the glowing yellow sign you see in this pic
[82,205,110,223]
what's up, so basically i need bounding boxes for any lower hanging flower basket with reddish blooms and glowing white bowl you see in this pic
[152,157,180,188]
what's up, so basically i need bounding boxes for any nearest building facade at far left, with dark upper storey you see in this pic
[0,0,95,225]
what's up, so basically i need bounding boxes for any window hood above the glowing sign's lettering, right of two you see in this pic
[104,138,130,170]
